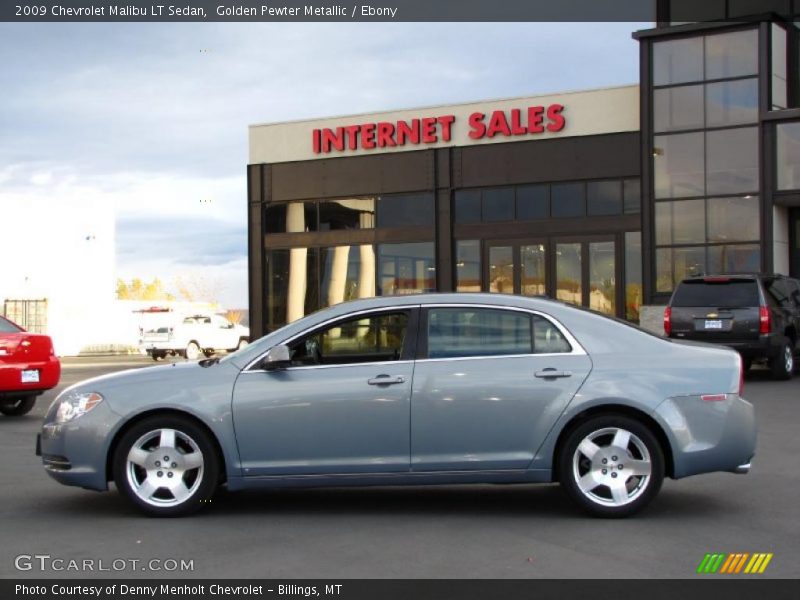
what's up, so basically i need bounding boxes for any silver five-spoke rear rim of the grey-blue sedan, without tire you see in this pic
[572,427,652,507]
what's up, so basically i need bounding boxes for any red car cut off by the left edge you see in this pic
[0,317,61,417]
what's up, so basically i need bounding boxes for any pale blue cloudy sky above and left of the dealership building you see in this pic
[0,23,650,308]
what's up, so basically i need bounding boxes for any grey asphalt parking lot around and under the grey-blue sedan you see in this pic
[0,357,800,579]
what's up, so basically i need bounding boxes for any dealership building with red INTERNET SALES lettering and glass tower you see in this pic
[248,0,800,334]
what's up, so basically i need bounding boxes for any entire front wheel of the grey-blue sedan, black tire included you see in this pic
[112,415,221,517]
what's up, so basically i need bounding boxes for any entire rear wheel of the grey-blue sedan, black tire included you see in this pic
[557,414,664,518]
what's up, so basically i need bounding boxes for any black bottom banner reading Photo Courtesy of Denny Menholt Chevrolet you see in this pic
[0,575,800,600]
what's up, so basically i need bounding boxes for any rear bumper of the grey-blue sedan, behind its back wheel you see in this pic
[655,394,756,479]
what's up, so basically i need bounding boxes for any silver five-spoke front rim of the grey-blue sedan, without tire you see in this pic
[126,429,204,507]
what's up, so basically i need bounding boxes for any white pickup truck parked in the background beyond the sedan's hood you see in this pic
[139,314,250,360]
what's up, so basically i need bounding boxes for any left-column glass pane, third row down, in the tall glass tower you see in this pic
[653,133,705,198]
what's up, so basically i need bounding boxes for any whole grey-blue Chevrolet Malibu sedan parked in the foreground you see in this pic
[38,294,756,517]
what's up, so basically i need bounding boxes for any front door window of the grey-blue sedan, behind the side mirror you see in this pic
[289,312,408,366]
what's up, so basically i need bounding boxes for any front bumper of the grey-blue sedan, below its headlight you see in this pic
[36,402,119,490]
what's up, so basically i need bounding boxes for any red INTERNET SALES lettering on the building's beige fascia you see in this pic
[311,104,566,154]
